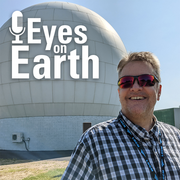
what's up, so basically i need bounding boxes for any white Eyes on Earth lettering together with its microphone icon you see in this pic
[9,11,99,79]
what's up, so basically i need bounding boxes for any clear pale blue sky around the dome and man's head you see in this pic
[0,0,180,110]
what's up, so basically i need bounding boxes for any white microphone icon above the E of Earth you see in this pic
[9,11,26,44]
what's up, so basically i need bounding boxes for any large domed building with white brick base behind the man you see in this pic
[0,2,126,151]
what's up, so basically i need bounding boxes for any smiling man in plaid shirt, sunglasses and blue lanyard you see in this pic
[62,52,180,180]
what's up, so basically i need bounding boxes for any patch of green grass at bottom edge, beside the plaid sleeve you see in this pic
[22,169,65,180]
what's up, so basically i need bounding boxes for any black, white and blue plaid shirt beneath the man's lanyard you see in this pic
[61,112,180,180]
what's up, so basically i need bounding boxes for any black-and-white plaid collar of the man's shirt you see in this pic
[119,111,159,141]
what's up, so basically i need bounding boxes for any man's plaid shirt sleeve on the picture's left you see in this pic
[61,142,95,180]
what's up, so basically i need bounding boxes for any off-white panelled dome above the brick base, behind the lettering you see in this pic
[0,2,126,119]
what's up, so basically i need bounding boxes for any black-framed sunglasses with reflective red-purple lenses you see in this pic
[118,74,159,88]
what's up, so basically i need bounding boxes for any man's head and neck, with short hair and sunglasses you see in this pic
[118,52,162,131]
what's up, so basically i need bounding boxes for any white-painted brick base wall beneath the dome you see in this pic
[0,115,115,151]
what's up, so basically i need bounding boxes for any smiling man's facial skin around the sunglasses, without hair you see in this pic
[118,61,161,118]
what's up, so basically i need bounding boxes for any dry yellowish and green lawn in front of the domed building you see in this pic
[0,159,68,180]
